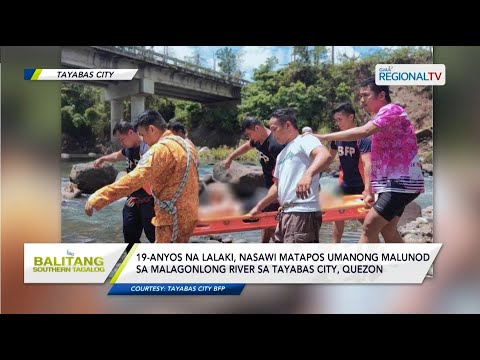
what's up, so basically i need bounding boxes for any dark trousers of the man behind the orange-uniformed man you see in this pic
[123,201,155,253]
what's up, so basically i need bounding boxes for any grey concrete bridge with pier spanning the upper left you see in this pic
[61,46,247,139]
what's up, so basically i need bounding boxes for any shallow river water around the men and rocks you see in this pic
[61,160,433,243]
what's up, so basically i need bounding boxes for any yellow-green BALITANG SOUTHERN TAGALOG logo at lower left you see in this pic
[33,250,105,273]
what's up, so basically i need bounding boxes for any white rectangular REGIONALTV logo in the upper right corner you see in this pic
[375,64,446,85]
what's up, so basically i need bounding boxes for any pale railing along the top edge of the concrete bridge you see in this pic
[98,46,248,86]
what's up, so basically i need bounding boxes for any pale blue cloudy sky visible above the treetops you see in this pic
[154,46,428,80]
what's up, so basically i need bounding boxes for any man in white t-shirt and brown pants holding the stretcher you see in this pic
[250,108,331,243]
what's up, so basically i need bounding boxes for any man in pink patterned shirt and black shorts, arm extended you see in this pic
[316,78,424,243]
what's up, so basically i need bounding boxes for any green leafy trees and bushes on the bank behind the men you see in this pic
[62,46,432,152]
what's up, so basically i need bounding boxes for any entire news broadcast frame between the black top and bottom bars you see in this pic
[0,44,480,314]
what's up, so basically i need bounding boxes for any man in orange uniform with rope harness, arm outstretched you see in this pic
[85,110,198,243]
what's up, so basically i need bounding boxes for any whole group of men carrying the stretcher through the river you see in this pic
[85,78,424,246]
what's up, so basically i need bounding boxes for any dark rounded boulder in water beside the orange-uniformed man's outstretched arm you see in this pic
[70,162,118,194]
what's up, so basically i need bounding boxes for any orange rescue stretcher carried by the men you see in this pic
[193,195,369,236]
